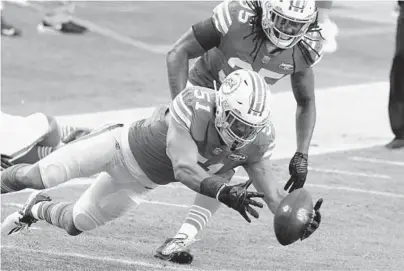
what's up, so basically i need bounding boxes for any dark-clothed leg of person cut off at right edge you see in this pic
[387,1,404,148]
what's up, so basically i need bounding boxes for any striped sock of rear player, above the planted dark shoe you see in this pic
[174,194,221,239]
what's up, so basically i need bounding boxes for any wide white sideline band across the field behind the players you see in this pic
[52,82,391,162]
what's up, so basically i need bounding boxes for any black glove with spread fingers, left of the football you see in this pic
[216,180,264,223]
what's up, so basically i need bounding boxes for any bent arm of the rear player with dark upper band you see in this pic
[166,18,221,99]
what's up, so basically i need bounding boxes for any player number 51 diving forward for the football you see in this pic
[1,70,321,258]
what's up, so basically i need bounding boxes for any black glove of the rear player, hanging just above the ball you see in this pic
[284,152,309,193]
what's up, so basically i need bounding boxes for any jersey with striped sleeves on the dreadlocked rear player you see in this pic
[189,0,323,88]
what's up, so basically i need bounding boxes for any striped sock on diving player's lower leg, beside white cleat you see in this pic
[31,201,81,235]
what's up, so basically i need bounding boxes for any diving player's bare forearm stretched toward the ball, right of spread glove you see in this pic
[244,157,285,214]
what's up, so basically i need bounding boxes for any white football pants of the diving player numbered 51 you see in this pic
[38,126,158,231]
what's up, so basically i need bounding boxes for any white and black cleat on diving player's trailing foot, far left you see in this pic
[1,191,51,235]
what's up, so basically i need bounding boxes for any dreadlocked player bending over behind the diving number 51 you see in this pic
[155,0,324,263]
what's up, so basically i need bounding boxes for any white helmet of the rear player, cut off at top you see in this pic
[261,0,317,49]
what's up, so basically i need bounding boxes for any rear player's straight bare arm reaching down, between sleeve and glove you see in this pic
[291,67,316,154]
